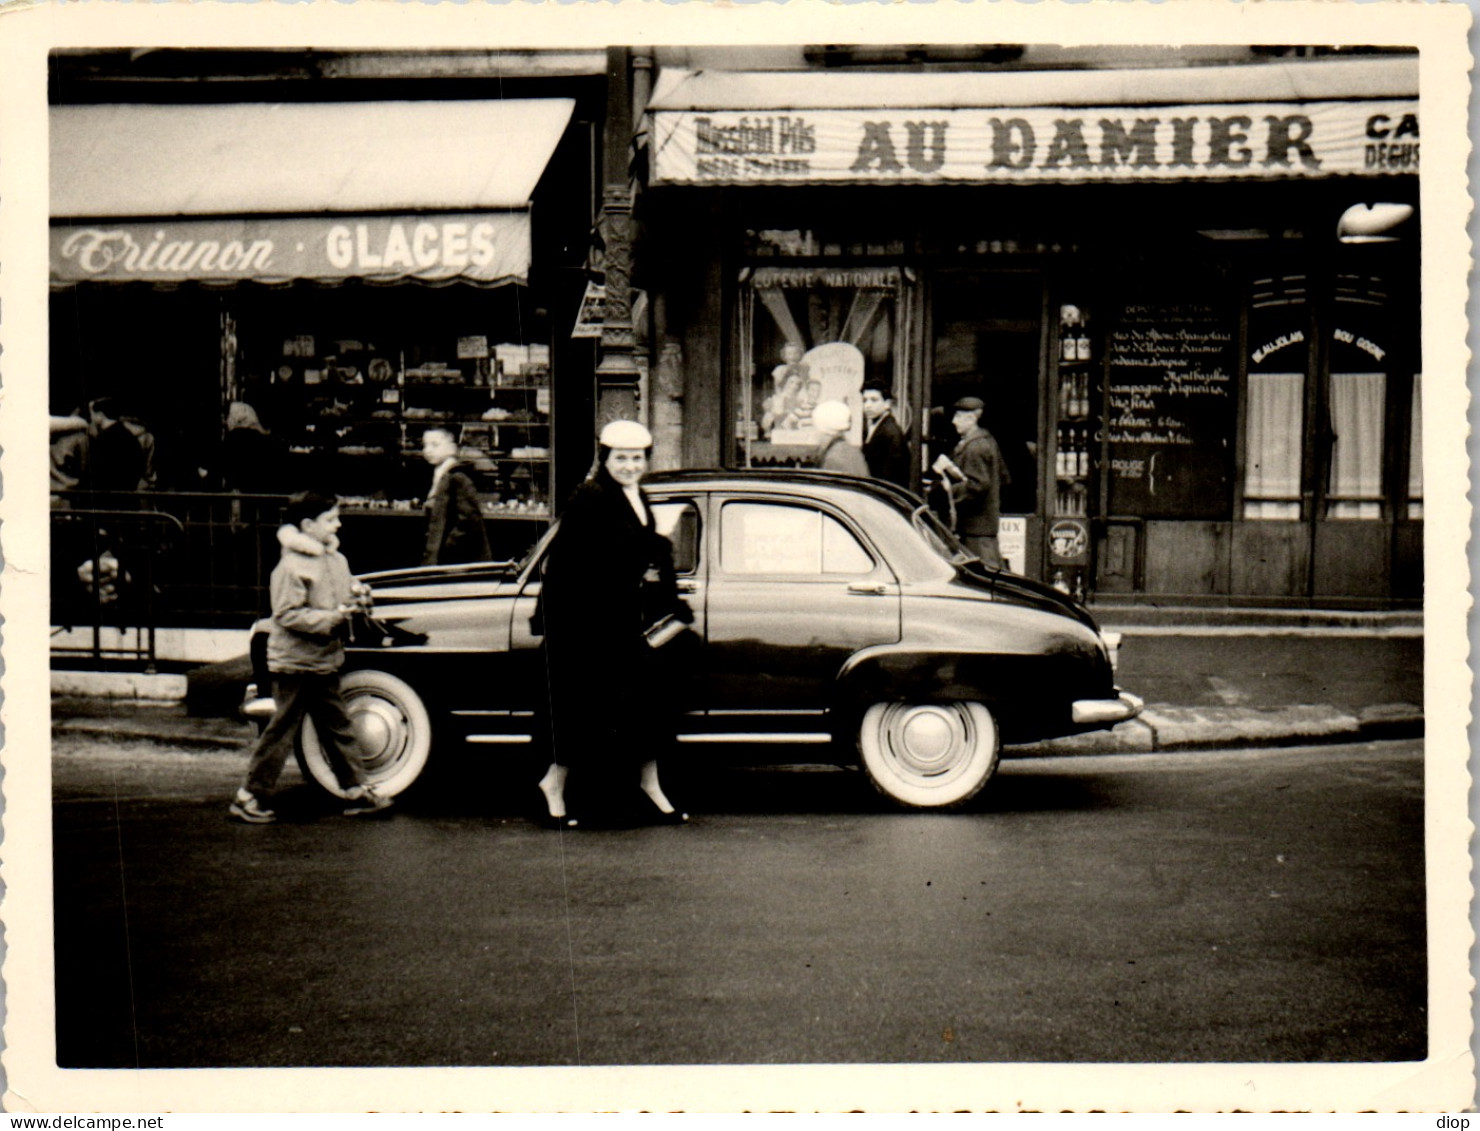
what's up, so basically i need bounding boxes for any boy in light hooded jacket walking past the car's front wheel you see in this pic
[231,491,391,825]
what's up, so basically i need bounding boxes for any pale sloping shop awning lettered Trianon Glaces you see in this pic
[50,99,574,284]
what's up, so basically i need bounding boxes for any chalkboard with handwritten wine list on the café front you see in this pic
[1104,299,1237,518]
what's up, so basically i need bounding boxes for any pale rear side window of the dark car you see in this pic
[719,502,873,577]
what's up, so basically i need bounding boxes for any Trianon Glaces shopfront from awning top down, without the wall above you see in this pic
[50,98,593,613]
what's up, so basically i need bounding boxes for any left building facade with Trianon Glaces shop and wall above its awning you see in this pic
[50,50,605,636]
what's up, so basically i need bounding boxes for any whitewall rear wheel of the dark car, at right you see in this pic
[858,703,1002,808]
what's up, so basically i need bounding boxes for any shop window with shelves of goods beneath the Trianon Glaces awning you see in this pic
[240,288,554,518]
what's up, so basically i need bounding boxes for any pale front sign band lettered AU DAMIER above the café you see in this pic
[653,99,1419,185]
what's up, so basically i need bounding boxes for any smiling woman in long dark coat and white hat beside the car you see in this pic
[539,420,693,828]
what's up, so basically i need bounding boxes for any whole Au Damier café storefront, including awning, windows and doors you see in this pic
[644,55,1424,607]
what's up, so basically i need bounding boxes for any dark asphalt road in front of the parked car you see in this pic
[53,737,1427,1067]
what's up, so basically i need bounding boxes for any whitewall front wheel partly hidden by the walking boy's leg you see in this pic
[297,671,432,796]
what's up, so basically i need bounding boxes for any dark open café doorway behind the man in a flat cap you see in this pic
[921,271,1046,577]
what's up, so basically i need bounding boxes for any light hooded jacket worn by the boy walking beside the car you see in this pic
[268,526,355,672]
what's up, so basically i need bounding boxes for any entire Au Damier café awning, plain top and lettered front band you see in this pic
[648,56,1418,184]
